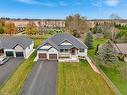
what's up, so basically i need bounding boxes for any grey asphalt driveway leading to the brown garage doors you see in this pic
[20,61,57,95]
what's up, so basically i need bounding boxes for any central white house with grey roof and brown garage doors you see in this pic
[37,33,88,61]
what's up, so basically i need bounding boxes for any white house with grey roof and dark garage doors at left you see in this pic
[0,36,34,58]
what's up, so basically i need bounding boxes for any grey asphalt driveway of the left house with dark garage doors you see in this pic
[0,58,23,85]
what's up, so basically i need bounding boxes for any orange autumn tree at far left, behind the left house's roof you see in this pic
[4,22,17,34]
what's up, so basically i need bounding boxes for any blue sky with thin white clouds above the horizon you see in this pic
[0,0,127,19]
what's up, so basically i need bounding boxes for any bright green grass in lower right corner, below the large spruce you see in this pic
[101,62,127,95]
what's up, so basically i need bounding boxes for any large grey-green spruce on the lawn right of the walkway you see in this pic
[97,40,118,64]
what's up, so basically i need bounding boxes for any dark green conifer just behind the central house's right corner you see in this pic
[84,32,93,49]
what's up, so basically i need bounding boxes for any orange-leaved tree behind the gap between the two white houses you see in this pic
[25,21,37,35]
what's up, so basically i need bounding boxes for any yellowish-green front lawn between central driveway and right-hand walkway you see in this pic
[58,60,114,95]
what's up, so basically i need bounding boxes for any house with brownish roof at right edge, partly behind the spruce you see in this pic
[114,43,127,57]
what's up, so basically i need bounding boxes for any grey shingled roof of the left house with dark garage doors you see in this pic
[0,36,32,49]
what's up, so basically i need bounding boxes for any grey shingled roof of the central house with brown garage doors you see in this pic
[38,33,88,50]
